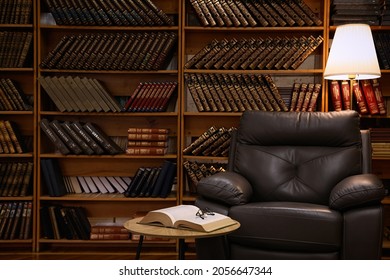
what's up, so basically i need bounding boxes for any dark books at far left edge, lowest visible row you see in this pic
[0,201,33,240]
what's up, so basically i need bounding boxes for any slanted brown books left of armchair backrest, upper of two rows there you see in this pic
[183,126,237,157]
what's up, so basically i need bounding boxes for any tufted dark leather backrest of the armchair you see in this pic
[229,110,363,205]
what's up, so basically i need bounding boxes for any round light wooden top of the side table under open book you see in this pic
[124,217,240,238]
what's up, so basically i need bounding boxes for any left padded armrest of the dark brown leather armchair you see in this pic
[197,171,253,205]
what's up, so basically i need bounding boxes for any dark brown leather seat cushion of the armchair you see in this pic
[229,201,343,253]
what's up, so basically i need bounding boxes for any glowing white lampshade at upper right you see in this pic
[324,24,381,80]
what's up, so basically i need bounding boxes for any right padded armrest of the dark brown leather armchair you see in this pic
[329,174,385,210]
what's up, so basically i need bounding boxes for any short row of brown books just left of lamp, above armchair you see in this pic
[289,83,322,112]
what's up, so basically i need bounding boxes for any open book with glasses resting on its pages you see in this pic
[139,205,237,232]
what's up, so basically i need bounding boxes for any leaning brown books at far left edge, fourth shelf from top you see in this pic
[0,120,27,154]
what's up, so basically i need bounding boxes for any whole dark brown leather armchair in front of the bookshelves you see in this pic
[195,110,385,259]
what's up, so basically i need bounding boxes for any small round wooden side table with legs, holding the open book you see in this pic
[124,217,240,260]
